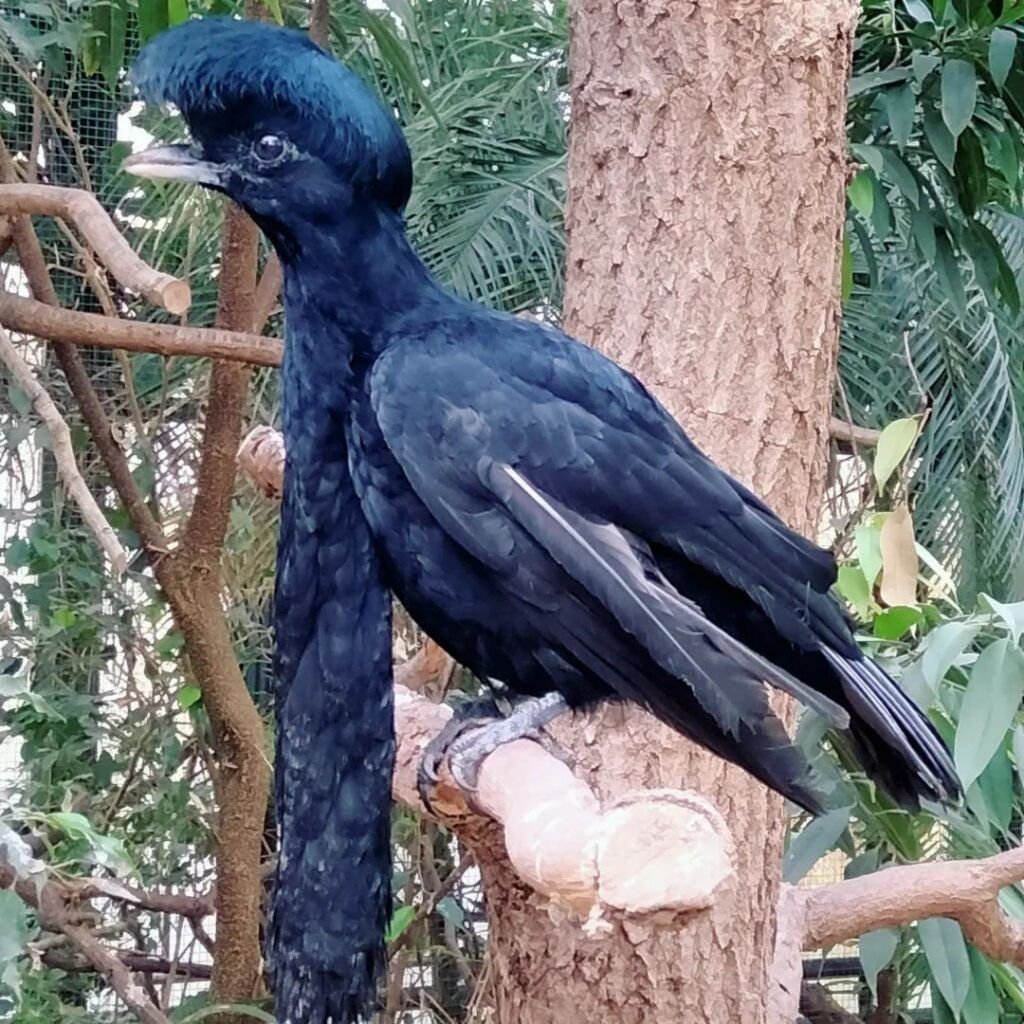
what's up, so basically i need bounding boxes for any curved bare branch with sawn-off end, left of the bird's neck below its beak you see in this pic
[0,184,191,316]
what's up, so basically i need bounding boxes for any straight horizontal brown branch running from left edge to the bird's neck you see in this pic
[0,292,283,367]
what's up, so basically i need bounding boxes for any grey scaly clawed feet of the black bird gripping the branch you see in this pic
[418,693,569,808]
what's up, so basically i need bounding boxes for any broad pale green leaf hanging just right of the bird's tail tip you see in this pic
[953,639,1024,790]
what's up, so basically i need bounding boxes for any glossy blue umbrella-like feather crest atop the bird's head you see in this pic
[131,17,412,207]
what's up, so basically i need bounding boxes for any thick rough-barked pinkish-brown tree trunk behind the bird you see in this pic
[484,0,859,1024]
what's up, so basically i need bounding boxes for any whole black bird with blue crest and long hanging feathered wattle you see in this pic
[129,19,959,1024]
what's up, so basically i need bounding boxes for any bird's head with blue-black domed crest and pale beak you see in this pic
[124,17,412,248]
